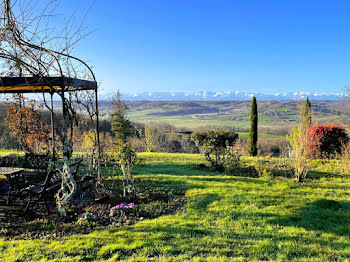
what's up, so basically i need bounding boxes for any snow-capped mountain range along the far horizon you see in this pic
[99,91,347,101]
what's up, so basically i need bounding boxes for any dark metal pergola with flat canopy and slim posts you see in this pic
[0,76,101,213]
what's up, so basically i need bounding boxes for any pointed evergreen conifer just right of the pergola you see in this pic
[111,90,131,143]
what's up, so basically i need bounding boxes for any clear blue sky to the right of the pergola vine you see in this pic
[56,0,350,93]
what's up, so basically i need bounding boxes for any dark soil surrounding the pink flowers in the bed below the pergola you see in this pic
[0,182,186,239]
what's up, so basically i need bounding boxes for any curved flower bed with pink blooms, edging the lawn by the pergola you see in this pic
[0,186,185,239]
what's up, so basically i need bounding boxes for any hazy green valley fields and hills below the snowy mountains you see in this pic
[122,101,349,129]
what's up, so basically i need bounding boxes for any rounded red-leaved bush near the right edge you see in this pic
[308,124,349,159]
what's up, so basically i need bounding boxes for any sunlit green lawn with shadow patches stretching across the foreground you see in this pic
[0,153,350,261]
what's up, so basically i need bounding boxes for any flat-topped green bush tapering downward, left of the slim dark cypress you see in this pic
[192,131,238,171]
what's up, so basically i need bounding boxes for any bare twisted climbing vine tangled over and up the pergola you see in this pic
[0,0,101,215]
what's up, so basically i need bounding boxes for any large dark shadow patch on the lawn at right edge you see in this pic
[271,199,350,236]
